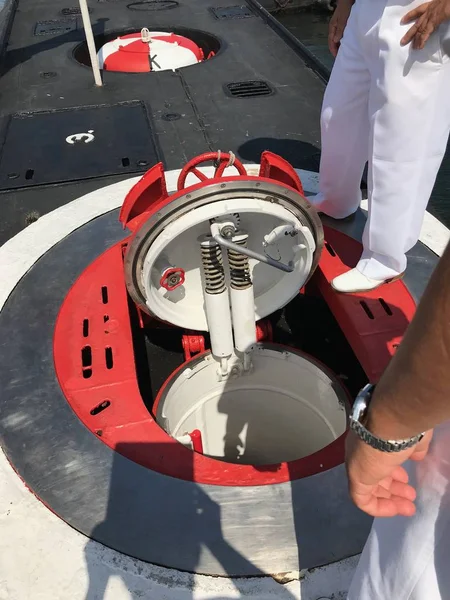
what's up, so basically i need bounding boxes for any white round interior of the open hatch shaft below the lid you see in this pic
[157,346,347,465]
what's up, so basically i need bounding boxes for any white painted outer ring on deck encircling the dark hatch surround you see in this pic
[0,165,450,600]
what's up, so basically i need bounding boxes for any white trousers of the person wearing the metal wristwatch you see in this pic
[348,423,450,600]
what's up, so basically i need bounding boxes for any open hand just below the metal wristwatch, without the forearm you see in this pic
[346,431,432,517]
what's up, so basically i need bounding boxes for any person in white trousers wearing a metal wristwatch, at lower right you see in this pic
[346,239,450,600]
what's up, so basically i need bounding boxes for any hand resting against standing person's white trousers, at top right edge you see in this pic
[400,0,450,50]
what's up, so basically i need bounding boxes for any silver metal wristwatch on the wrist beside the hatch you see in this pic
[350,383,425,452]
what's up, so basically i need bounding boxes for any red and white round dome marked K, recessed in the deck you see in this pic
[97,29,204,73]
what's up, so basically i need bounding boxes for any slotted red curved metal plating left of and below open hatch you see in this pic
[54,244,345,486]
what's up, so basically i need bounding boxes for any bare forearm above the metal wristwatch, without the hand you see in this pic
[369,240,450,439]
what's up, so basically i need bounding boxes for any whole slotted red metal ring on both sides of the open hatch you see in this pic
[54,229,415,486]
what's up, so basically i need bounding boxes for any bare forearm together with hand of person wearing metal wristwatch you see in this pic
[346,241,450,516]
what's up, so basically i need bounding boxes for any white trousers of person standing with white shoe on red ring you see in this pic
[313,0,450,279]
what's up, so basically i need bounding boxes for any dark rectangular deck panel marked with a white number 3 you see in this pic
[0,102,158,190]
